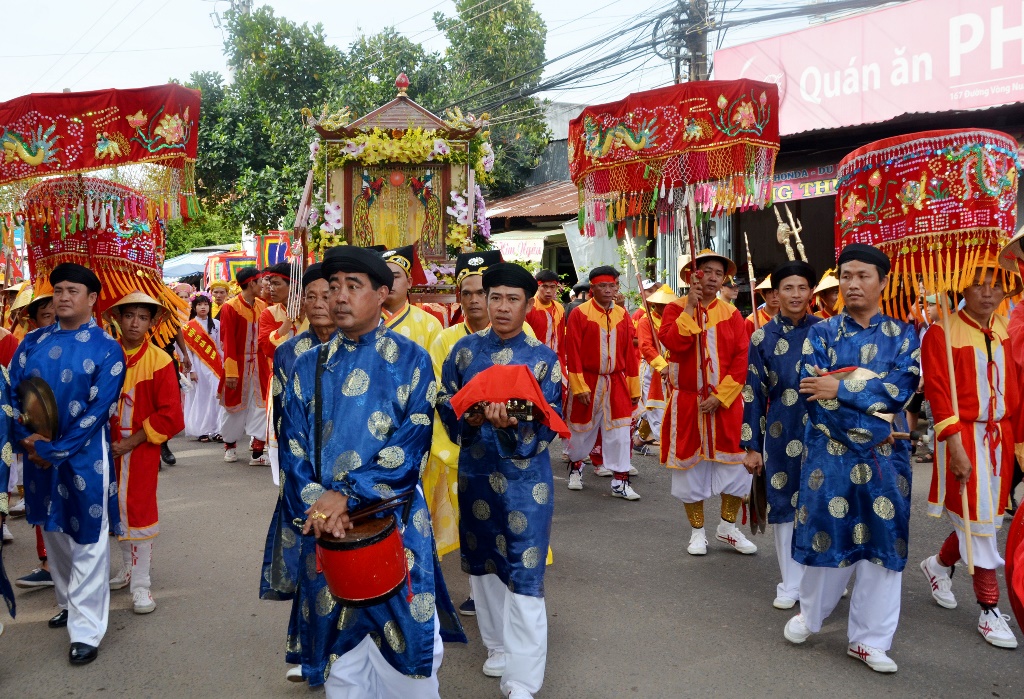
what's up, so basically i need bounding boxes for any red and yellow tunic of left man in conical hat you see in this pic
[111,341,185,540]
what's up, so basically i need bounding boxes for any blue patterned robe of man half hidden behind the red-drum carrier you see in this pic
[259,331,321,664]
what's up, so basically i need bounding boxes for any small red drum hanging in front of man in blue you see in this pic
[316,513,409,607]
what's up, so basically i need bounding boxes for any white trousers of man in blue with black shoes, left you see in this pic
[43,441,111,646]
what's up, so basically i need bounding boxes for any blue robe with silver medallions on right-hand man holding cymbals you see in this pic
[793,312,921,571]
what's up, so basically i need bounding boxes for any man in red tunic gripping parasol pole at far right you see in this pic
[921,263,1020,648]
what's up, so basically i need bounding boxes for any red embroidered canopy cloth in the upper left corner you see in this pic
[0,85,200,184]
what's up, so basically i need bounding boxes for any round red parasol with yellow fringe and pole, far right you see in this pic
[836,129,1021,575]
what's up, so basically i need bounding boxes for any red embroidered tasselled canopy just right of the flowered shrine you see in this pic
[568,80,779,232]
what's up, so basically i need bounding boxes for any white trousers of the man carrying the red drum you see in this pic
[324,614,444,699]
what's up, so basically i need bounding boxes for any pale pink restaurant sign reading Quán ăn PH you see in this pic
[715,0,1024,135]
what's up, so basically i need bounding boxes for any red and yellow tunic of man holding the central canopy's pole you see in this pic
[657,299,751,470]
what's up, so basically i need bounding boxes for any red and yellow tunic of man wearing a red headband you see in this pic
[565,299,640,432]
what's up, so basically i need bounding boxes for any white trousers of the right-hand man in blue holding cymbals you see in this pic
[800,561,903,651]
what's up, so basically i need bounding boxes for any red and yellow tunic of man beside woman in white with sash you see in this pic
[220,294,269,412]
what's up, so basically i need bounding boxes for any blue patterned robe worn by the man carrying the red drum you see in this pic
[280,325,465,686]
